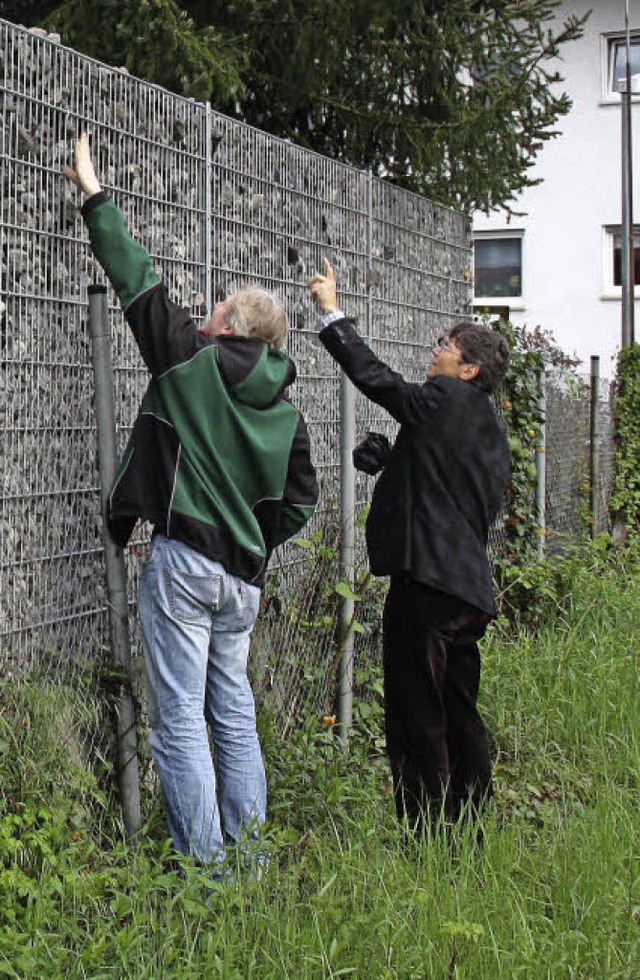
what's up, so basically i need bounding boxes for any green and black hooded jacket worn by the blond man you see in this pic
[82,193,318,585]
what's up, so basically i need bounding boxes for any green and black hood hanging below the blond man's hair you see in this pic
[216,336,296,408]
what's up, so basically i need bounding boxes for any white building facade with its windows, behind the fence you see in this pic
[473,0,640,376]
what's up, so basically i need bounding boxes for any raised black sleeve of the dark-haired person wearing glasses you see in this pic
[320,319,439,425]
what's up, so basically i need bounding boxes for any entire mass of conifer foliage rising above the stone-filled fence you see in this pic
[13,0,588,211]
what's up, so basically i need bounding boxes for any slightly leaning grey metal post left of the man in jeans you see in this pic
[89,285,142,839]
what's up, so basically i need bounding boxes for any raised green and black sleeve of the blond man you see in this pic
[82,192,209,377]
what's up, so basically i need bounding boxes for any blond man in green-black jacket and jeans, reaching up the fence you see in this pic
[64,135,318,873]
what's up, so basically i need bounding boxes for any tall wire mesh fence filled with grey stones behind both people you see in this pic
[0,21,610,756]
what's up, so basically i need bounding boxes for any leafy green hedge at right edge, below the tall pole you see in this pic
[611,344,640,536]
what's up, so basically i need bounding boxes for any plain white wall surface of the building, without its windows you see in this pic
[473,0,640,376]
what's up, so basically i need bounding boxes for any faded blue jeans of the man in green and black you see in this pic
[138,535,267,864]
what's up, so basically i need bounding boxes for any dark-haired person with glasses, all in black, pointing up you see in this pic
[309,260,510,829]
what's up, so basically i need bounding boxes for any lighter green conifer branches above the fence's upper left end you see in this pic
[47,0,248,101]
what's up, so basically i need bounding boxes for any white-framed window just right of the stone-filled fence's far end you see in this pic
[473,232,522,305]
